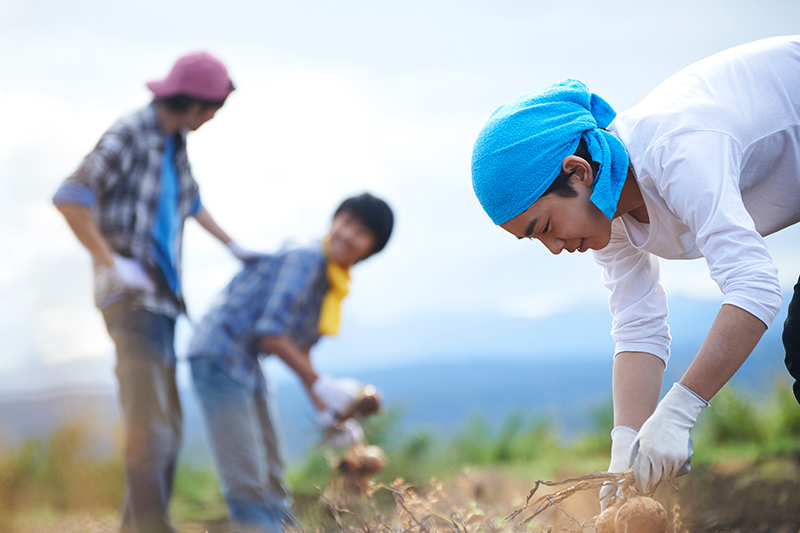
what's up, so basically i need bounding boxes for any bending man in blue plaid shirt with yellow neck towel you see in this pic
[189,194,393,532]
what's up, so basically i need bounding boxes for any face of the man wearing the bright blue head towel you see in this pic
[500,177,611,254]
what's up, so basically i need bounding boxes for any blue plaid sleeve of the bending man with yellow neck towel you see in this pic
[255,251,316,336]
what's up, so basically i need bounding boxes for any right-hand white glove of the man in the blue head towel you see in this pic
[628,383,708,494]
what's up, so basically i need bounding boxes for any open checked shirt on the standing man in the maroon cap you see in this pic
[54,103,200,317]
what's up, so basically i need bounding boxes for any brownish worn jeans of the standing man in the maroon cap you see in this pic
[103,298,182,533]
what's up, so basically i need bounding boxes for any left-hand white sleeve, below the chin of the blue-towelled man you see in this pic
[594,220,670,364]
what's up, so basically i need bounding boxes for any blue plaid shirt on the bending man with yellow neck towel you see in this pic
[188,243,328,394]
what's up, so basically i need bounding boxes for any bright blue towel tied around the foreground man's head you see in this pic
[472,79,628,224]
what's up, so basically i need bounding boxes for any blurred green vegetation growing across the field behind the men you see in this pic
[0,380,800,533]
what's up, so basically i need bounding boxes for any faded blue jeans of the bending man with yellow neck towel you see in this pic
[189,356,294,533]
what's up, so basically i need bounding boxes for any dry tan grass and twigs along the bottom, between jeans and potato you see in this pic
[291,472,676,533]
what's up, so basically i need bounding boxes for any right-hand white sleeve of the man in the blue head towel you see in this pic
[654,132,782,326]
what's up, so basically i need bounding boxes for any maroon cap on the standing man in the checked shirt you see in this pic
[147,52,234,102]
